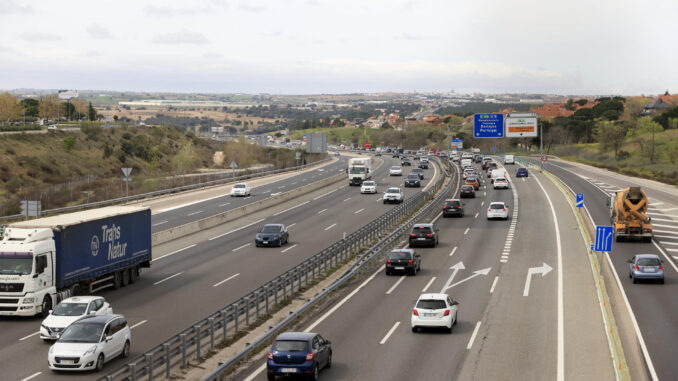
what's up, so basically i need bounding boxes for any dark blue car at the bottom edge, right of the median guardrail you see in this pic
[266,332,332,380]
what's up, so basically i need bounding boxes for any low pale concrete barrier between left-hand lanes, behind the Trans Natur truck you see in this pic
[151,172,346,246]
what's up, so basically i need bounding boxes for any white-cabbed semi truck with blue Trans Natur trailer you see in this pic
[0,206,151,316]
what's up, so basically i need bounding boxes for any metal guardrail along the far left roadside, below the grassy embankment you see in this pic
[0,157,332,221]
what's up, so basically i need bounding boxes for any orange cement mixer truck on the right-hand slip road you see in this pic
[608,187,652,242]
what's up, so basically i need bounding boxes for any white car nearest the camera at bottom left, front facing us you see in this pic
[47,315,132,371]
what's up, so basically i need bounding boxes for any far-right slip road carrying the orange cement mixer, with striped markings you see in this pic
[532,157,678,380]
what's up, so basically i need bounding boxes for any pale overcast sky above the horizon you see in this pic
[0,0,678,95]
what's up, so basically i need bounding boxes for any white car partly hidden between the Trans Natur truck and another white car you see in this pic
[40,296,113,341]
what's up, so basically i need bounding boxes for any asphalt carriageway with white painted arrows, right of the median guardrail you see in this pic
[235,158,615,381]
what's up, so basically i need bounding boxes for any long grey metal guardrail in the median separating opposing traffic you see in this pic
[100,155,452,381]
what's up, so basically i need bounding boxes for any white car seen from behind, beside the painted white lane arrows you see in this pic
[410,294,459,333]
